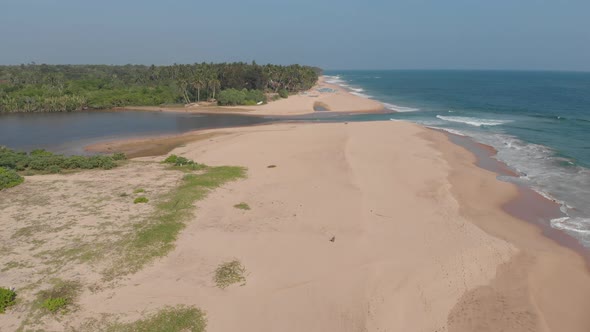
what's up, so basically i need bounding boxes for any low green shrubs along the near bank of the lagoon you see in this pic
[0,147,118,173]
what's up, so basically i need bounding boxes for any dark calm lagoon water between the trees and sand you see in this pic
[0,111,274,154]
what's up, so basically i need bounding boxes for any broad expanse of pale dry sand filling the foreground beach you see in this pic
[0,121,590,332]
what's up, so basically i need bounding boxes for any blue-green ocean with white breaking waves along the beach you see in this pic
[325,70,590,248]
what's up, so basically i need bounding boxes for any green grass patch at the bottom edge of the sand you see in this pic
[106,306,207,332]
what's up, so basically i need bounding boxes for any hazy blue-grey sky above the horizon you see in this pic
[0,0,590,70]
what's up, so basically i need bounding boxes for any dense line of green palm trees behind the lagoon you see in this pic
[0,62,320,112]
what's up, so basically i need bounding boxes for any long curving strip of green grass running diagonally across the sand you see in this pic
[105,166,246,280]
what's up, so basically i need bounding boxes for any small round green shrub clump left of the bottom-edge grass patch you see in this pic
[37,279,81,313]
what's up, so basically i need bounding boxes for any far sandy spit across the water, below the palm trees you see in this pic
[117,76,385,116]
